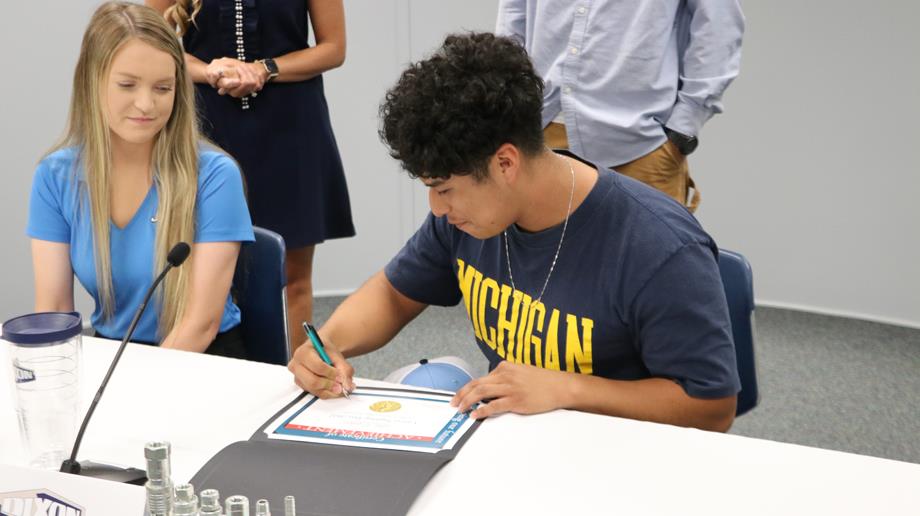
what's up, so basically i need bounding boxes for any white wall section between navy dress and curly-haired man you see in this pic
[314,0,497,295]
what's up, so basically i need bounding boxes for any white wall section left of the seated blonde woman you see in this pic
[0,0,98,320]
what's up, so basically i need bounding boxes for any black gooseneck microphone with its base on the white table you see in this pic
[60,242,191,485]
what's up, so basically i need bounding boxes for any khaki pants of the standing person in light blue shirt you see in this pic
[543,122,700,213]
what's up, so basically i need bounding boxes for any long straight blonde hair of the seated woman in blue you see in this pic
[51,2,200,337]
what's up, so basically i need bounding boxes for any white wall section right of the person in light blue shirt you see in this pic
[691,0,920,327]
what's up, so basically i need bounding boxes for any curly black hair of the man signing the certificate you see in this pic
[379,32,543,180]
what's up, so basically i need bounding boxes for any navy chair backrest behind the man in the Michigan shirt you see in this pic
[719,249,760,416]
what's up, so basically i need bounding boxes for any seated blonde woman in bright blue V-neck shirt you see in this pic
[27,2,253,356]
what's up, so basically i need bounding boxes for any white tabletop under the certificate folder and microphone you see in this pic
[0,338,920,516]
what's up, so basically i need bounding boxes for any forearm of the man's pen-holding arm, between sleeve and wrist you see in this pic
[319,271,425,357]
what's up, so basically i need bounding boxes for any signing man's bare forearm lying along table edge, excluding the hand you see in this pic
[564,375,736,432]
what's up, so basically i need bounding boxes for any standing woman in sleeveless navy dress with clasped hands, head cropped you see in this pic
[147,0,355,346]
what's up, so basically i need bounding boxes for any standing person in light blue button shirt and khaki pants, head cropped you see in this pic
[496,0,744,212]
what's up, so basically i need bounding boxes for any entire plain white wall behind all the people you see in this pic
[0,0,920,327]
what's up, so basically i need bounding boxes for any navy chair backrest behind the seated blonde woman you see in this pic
[232,227,291,365]
